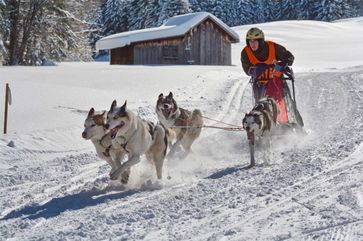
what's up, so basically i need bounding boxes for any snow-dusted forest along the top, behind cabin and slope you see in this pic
[0,0,363,65]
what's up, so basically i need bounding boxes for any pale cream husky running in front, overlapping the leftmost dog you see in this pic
[105,100,168,183]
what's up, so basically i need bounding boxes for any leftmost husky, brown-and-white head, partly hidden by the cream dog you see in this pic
[82,108,129,183]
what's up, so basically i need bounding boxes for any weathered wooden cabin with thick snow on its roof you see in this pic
[96,12,239,65]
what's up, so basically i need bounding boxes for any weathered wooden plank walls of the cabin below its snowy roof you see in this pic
[111,19,235,65]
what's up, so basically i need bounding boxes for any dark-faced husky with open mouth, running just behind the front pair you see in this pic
[156,92,203,159]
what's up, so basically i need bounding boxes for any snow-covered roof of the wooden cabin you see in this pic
[96,12,239,50]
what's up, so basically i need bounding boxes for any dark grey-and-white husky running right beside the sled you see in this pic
[242,97,279,167]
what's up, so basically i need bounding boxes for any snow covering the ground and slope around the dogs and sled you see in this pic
[0,18,363,240]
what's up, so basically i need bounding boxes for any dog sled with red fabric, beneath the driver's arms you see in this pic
[250,64,305,136]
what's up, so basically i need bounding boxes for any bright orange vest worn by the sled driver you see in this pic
[245,41,281,85]
